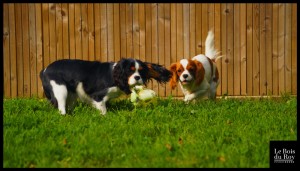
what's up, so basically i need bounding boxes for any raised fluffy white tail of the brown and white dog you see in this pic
[205,30,222,62]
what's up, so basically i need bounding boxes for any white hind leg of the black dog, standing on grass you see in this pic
[50,80,68,115]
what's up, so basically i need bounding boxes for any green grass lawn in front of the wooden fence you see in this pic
[3,97,297,168]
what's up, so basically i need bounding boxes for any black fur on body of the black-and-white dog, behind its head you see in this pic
[44,59,113,95]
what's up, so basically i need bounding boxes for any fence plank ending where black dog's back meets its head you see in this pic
[107,3,115,62]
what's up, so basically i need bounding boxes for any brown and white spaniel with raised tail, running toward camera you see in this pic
[170,31,219,102]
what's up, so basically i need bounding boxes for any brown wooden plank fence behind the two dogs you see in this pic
[3,3,297,98]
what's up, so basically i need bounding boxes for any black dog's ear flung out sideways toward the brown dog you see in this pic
[145,62,172,83]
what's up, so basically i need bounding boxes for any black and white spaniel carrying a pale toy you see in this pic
[40,58,172,115]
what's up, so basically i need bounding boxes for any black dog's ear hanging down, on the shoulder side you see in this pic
[113,58,131,94]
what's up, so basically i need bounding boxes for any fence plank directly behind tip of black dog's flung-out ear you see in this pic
[163,4,171,97]
